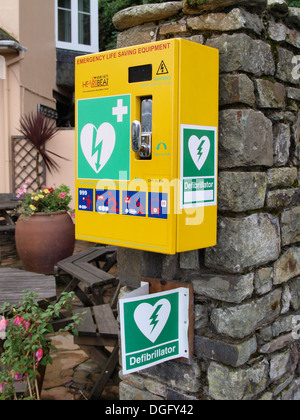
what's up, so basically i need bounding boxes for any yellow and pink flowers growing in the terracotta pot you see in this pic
[16,179,72,216]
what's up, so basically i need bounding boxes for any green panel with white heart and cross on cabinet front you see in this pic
[77,95,130,181]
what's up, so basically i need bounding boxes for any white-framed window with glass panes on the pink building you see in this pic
[55,0,99,52]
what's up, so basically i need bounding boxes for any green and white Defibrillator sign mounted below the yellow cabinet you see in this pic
[120,288,189,374]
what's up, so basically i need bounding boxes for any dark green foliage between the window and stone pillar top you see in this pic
[99,0,172,51]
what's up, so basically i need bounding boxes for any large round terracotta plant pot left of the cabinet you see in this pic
[15,211,75,274]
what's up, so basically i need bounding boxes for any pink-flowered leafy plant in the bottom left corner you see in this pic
[0,292,79,400]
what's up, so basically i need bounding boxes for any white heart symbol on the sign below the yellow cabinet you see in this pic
[133,299,171,343]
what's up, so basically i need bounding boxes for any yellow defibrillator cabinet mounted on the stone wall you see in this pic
[75,39,219,254]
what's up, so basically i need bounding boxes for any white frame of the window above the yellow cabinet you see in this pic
[55,0,99,53]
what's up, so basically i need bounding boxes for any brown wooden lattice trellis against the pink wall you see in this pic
[11,136,46,193]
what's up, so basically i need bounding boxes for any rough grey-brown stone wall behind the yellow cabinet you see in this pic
[114,0,300,400]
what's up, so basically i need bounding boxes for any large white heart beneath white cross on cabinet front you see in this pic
[80,123,116,174]
